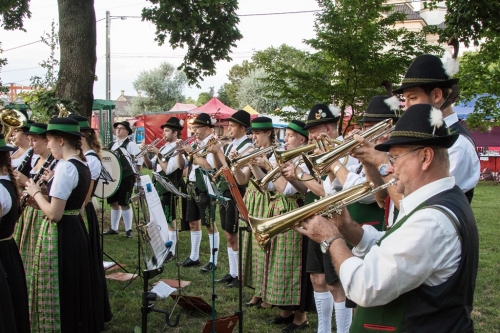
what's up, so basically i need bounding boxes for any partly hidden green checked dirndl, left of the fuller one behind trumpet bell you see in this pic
[242,183,270,297]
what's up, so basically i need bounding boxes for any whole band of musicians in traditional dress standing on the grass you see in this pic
[0,51,479,333]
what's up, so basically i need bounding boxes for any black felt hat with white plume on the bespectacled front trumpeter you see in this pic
[375,104,459,151]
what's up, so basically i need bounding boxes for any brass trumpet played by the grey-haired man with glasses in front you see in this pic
[249,179,396,252]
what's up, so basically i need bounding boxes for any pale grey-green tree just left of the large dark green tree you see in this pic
[236,68,283,113]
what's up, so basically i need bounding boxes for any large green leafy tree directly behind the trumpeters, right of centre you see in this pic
[254,0,442,132]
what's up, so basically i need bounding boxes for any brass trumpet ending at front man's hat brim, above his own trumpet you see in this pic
[302,119,394,181]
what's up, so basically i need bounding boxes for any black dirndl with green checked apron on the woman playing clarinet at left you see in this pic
[31,159,99,332]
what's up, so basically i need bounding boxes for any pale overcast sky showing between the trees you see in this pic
[0,0,328,99]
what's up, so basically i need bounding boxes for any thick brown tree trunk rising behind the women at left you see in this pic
[56,0,96,117]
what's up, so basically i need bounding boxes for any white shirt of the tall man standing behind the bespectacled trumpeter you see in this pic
[444,113,481,192]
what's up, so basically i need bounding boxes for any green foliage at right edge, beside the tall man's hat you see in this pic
[457,43,500,131]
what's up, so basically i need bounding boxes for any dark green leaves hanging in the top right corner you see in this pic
[424,0,500,46]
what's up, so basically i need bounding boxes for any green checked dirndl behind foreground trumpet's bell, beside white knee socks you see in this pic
[263,193,303,306]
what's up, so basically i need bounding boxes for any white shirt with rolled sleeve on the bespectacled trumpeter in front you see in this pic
[339,177,461,307]
